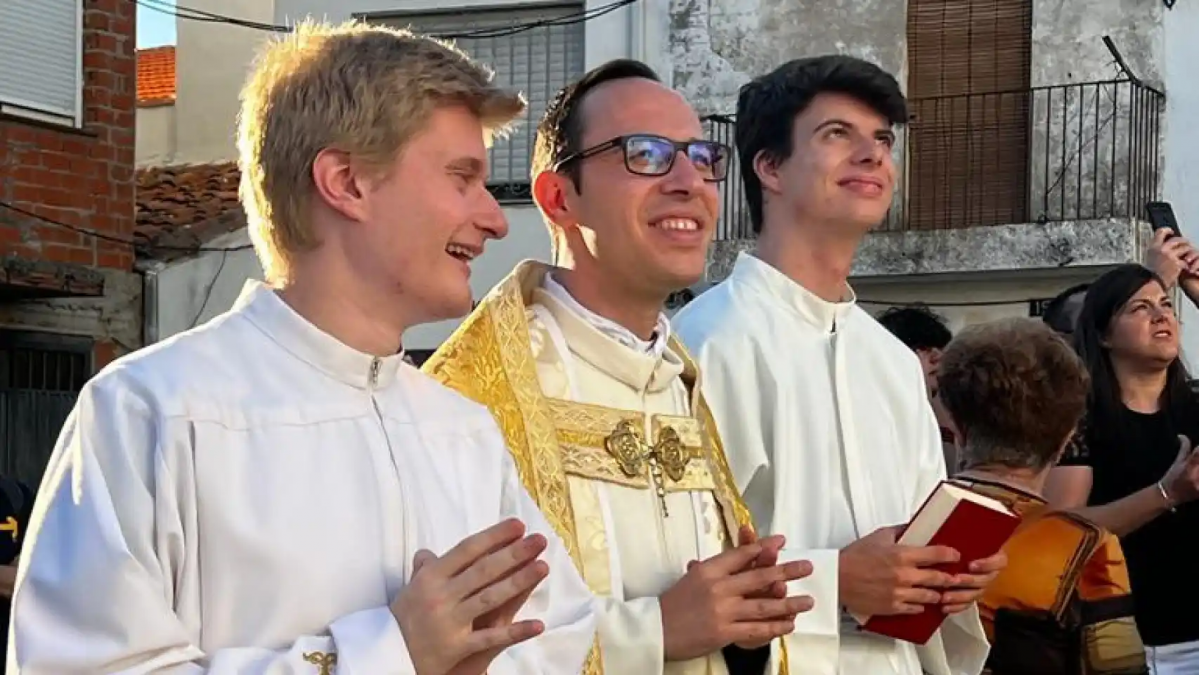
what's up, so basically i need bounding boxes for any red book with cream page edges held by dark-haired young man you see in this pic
[855,481,1020,645]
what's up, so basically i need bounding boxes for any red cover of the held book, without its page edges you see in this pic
[861,486,1020,645]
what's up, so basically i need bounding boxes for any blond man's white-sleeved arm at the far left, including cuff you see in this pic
[10,375,415,675]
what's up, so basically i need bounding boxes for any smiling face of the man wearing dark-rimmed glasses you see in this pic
[535,78,727,302]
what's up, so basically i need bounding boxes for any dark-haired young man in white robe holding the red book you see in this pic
[675,56,1005,675]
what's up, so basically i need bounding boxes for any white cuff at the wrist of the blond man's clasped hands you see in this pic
[329,607,416,675]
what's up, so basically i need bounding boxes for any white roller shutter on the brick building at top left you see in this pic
[0,0,83,121]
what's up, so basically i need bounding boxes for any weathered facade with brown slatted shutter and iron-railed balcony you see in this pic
[667,0,1199,355]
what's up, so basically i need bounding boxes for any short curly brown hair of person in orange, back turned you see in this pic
[938,319,1091,470]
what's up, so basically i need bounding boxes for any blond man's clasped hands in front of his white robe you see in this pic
[391,519,549,675]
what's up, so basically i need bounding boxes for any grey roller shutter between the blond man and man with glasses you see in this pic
[386,5,585,193]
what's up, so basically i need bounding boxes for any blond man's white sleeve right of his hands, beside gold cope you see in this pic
[487,428,596,675]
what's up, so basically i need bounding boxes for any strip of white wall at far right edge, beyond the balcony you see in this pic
[1162,2,1199,366]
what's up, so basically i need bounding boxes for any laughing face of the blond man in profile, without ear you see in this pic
[347,107,507,324]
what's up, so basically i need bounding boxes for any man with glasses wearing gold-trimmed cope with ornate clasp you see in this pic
[424,60,811,675]
